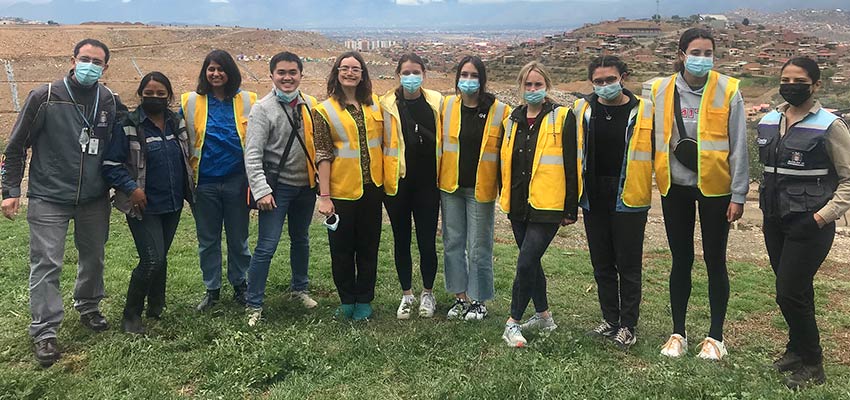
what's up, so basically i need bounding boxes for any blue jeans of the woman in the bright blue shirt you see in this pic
[192,174,251,290]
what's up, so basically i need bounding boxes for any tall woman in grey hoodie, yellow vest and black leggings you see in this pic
[652,28,749,360]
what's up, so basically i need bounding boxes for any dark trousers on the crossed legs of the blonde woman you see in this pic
[511,221,560,321]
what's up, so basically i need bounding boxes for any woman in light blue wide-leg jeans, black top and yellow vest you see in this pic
[438,56,511,320]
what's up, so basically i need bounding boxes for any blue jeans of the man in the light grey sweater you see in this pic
[246,183,316,308]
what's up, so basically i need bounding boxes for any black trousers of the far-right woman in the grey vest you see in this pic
[762,213,835,365]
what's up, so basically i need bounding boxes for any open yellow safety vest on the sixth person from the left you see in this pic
[381,88,443,196]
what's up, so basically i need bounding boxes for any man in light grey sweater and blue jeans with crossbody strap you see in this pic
[245,52,317,326]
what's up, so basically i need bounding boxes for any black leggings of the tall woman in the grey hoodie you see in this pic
[661,185,732,341]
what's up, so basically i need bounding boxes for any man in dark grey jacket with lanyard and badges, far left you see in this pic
[2,39,121,367]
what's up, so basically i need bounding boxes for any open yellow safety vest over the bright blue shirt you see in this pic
[180,90,257,183]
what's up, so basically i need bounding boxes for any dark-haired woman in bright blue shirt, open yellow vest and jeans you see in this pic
[180,50,257,311]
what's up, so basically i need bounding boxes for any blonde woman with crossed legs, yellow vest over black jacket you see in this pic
[499,61,578,347]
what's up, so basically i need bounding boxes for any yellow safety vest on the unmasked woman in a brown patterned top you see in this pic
[316,95,384,200]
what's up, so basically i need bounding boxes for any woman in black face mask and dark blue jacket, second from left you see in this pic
[103,72,194,334]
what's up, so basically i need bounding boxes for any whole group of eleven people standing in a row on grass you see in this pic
[2,28,850,388]
